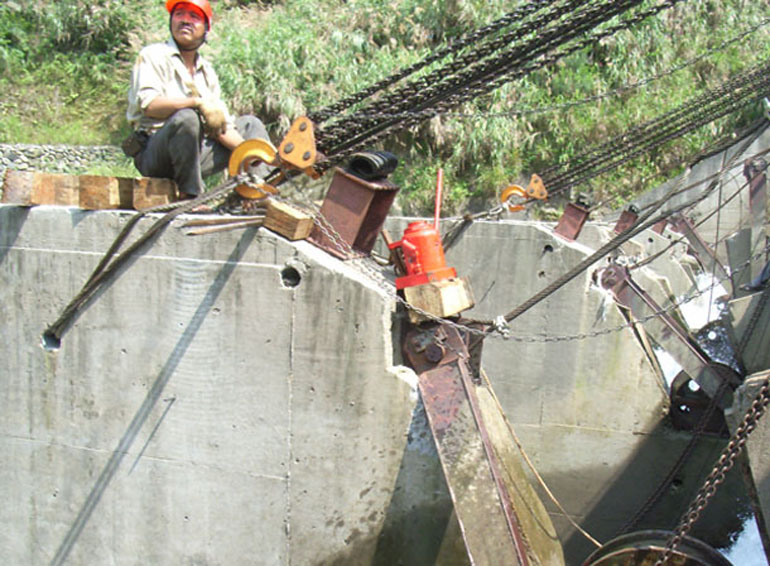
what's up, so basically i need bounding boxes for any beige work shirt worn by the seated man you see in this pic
[126,38,235,133]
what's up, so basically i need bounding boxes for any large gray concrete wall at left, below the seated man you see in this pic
[0,206,416,565]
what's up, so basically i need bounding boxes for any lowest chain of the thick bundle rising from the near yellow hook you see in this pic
[319,0,683,171]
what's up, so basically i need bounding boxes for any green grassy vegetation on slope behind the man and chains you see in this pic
[0,0,770,212]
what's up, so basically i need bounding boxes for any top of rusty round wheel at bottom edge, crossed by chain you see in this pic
[583,530,732,566]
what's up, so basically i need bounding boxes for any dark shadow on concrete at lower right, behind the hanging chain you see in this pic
[560,421,749,564]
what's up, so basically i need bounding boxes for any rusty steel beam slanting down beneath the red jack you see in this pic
[404,324,564,566]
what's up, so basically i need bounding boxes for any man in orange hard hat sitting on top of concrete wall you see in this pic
[123,0,269,203]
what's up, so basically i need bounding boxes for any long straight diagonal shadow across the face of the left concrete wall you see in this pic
[51,229,256,566]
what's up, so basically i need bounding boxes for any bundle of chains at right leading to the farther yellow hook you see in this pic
[540,61,770,192]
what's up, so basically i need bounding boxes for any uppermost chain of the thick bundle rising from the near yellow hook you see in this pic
[308,0,552,124]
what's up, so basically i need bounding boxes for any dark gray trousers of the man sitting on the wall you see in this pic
[134,108,270,196]
